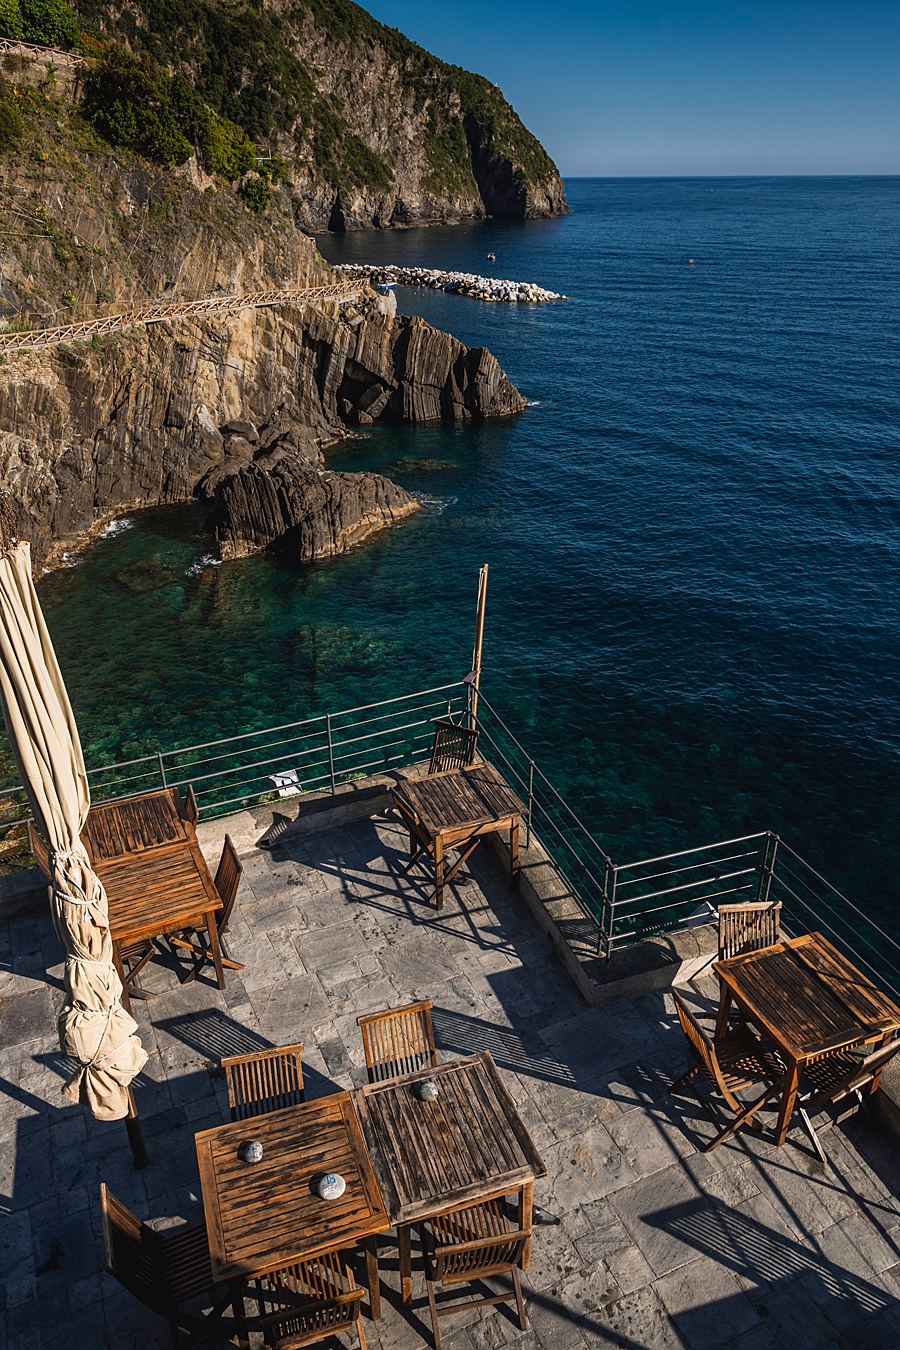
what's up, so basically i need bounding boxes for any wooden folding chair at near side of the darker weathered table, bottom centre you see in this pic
[420,1196,532,1350]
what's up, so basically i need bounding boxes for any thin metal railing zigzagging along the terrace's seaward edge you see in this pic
[0,676,900,999]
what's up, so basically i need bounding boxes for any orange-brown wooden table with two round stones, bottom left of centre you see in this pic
[194,1092,390,1346]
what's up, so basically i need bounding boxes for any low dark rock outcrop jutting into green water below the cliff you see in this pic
[200,454,418,563]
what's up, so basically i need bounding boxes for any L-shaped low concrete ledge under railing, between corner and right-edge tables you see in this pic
[488,834,718,1007]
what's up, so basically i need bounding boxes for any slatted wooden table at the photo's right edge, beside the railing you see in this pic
[712,933,900,1145]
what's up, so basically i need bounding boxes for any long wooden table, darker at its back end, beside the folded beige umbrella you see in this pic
[82,788,225,1008]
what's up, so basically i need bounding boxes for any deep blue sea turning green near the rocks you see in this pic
[31,178,900,910]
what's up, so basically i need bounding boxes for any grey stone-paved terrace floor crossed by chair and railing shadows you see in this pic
[0,815,900,1350]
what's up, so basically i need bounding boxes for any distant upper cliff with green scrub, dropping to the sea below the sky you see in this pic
[0,0,567,230]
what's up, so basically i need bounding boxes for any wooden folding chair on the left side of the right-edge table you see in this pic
[669,990,785,1153]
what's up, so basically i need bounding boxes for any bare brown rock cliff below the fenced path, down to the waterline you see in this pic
[0,297,524,566]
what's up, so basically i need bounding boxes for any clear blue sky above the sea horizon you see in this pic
[366,0,900,176]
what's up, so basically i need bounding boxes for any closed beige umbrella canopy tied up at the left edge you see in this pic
[0,521,147,1121]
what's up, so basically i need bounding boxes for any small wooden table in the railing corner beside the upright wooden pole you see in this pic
[391,764,525,910]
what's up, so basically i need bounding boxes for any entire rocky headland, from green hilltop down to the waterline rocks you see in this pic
[0,0,558,568]
